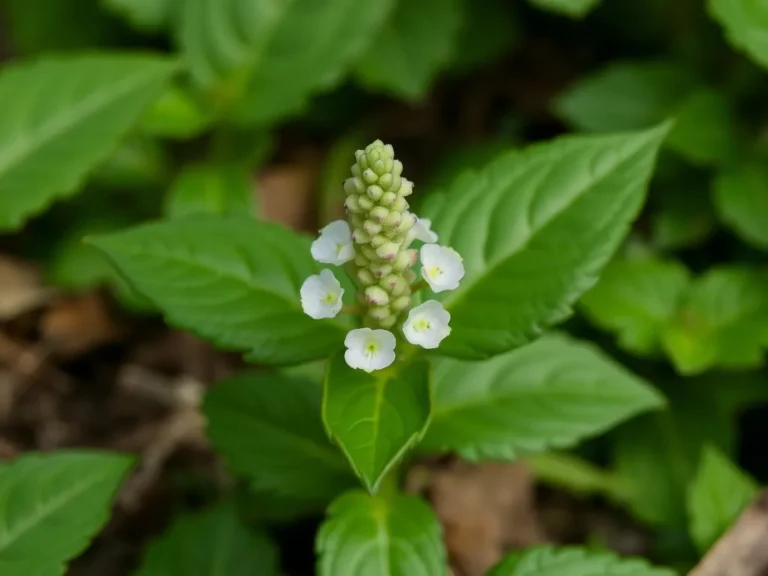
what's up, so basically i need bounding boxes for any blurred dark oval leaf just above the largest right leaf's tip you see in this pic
[555,61,695,132]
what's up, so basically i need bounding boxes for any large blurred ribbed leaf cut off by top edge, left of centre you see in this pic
[181,0,392,125]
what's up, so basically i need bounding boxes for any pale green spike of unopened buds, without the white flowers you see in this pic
[344,140,418,329]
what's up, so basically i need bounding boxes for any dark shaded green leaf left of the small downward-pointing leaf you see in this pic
[203,374,355,504]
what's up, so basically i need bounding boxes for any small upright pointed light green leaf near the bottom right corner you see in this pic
[687,446,758,554]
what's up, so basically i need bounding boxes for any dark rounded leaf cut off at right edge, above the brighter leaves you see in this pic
[714,160,768,249]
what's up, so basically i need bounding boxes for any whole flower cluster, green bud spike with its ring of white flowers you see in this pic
[301,140,464,372]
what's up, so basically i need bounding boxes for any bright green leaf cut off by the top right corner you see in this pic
[708,0,768,68]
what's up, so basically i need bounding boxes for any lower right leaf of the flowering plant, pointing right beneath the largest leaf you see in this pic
[420,336,664,460]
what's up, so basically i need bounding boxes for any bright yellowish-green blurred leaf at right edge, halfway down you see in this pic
[662,267,768,375]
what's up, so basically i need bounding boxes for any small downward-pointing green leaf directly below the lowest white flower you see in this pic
[323,355,431,492]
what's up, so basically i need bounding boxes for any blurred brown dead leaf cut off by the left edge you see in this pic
[0,255,54,321]
